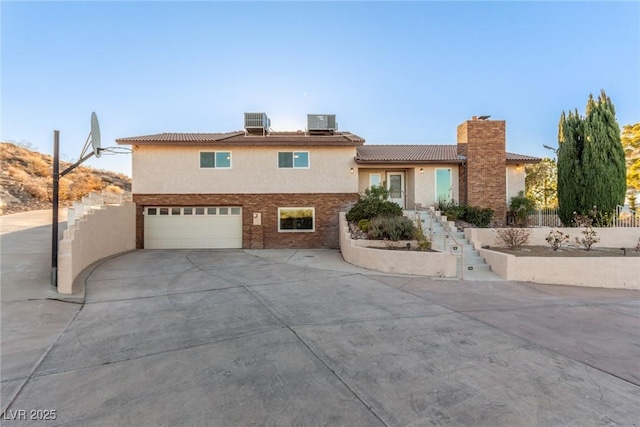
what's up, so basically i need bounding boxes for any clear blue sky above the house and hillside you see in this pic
[0,1,640,174]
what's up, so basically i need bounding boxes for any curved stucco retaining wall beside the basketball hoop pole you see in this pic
[58,202,136,294]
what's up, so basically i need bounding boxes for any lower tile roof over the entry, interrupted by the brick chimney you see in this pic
[355,144,540,163]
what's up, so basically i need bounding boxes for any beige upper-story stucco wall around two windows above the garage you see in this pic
[132,145,358,194]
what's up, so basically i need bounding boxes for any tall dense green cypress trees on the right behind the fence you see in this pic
[558,91,626,225]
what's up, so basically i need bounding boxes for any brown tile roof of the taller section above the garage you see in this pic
[116,131,364,146]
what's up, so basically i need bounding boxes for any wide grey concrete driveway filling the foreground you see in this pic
[2,213,640,426]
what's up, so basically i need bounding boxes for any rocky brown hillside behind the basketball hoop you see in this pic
[0,142,131,215]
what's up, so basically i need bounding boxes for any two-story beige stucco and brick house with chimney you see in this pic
[116,113,540,249]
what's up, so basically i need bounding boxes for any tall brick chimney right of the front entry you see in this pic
[458,116,507,223]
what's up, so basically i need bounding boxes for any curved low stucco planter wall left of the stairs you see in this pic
[340,212,457,277]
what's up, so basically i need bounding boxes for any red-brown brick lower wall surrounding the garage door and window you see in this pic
[133,193,358,249]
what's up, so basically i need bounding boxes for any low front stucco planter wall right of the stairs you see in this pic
[479,249,640,289]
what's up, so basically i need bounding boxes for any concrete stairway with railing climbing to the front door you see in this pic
[404,211,504,281]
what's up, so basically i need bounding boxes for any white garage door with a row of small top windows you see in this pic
[144,206,242,249]
